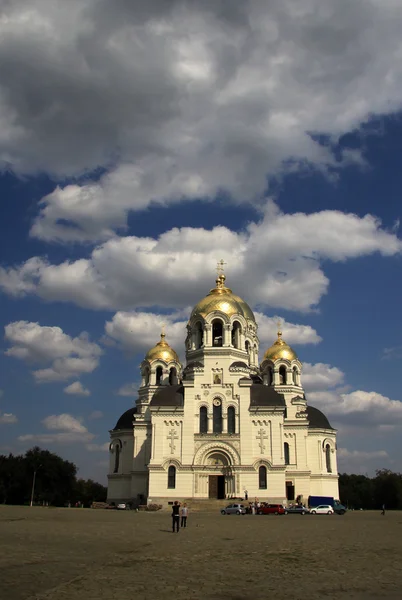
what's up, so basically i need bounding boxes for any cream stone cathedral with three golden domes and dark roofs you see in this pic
[108,261,338,504]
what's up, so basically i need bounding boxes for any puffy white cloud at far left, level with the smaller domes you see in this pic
[5,321,102,382]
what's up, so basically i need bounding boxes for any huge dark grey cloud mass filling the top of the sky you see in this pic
[0,0,402,240]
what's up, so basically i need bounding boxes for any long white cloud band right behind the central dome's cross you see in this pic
[0,202,402,311]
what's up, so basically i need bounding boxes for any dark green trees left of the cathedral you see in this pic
[0,447,107,506]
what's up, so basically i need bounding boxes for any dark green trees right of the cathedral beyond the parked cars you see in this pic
[339,469,402,510]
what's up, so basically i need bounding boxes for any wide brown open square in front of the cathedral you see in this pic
[0,506,402,600]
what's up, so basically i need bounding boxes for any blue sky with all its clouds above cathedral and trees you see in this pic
[0,0,402,482]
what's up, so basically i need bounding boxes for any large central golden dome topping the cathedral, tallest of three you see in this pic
[190,273,255,321]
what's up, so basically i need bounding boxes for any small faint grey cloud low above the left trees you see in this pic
[18,413,95,444]
